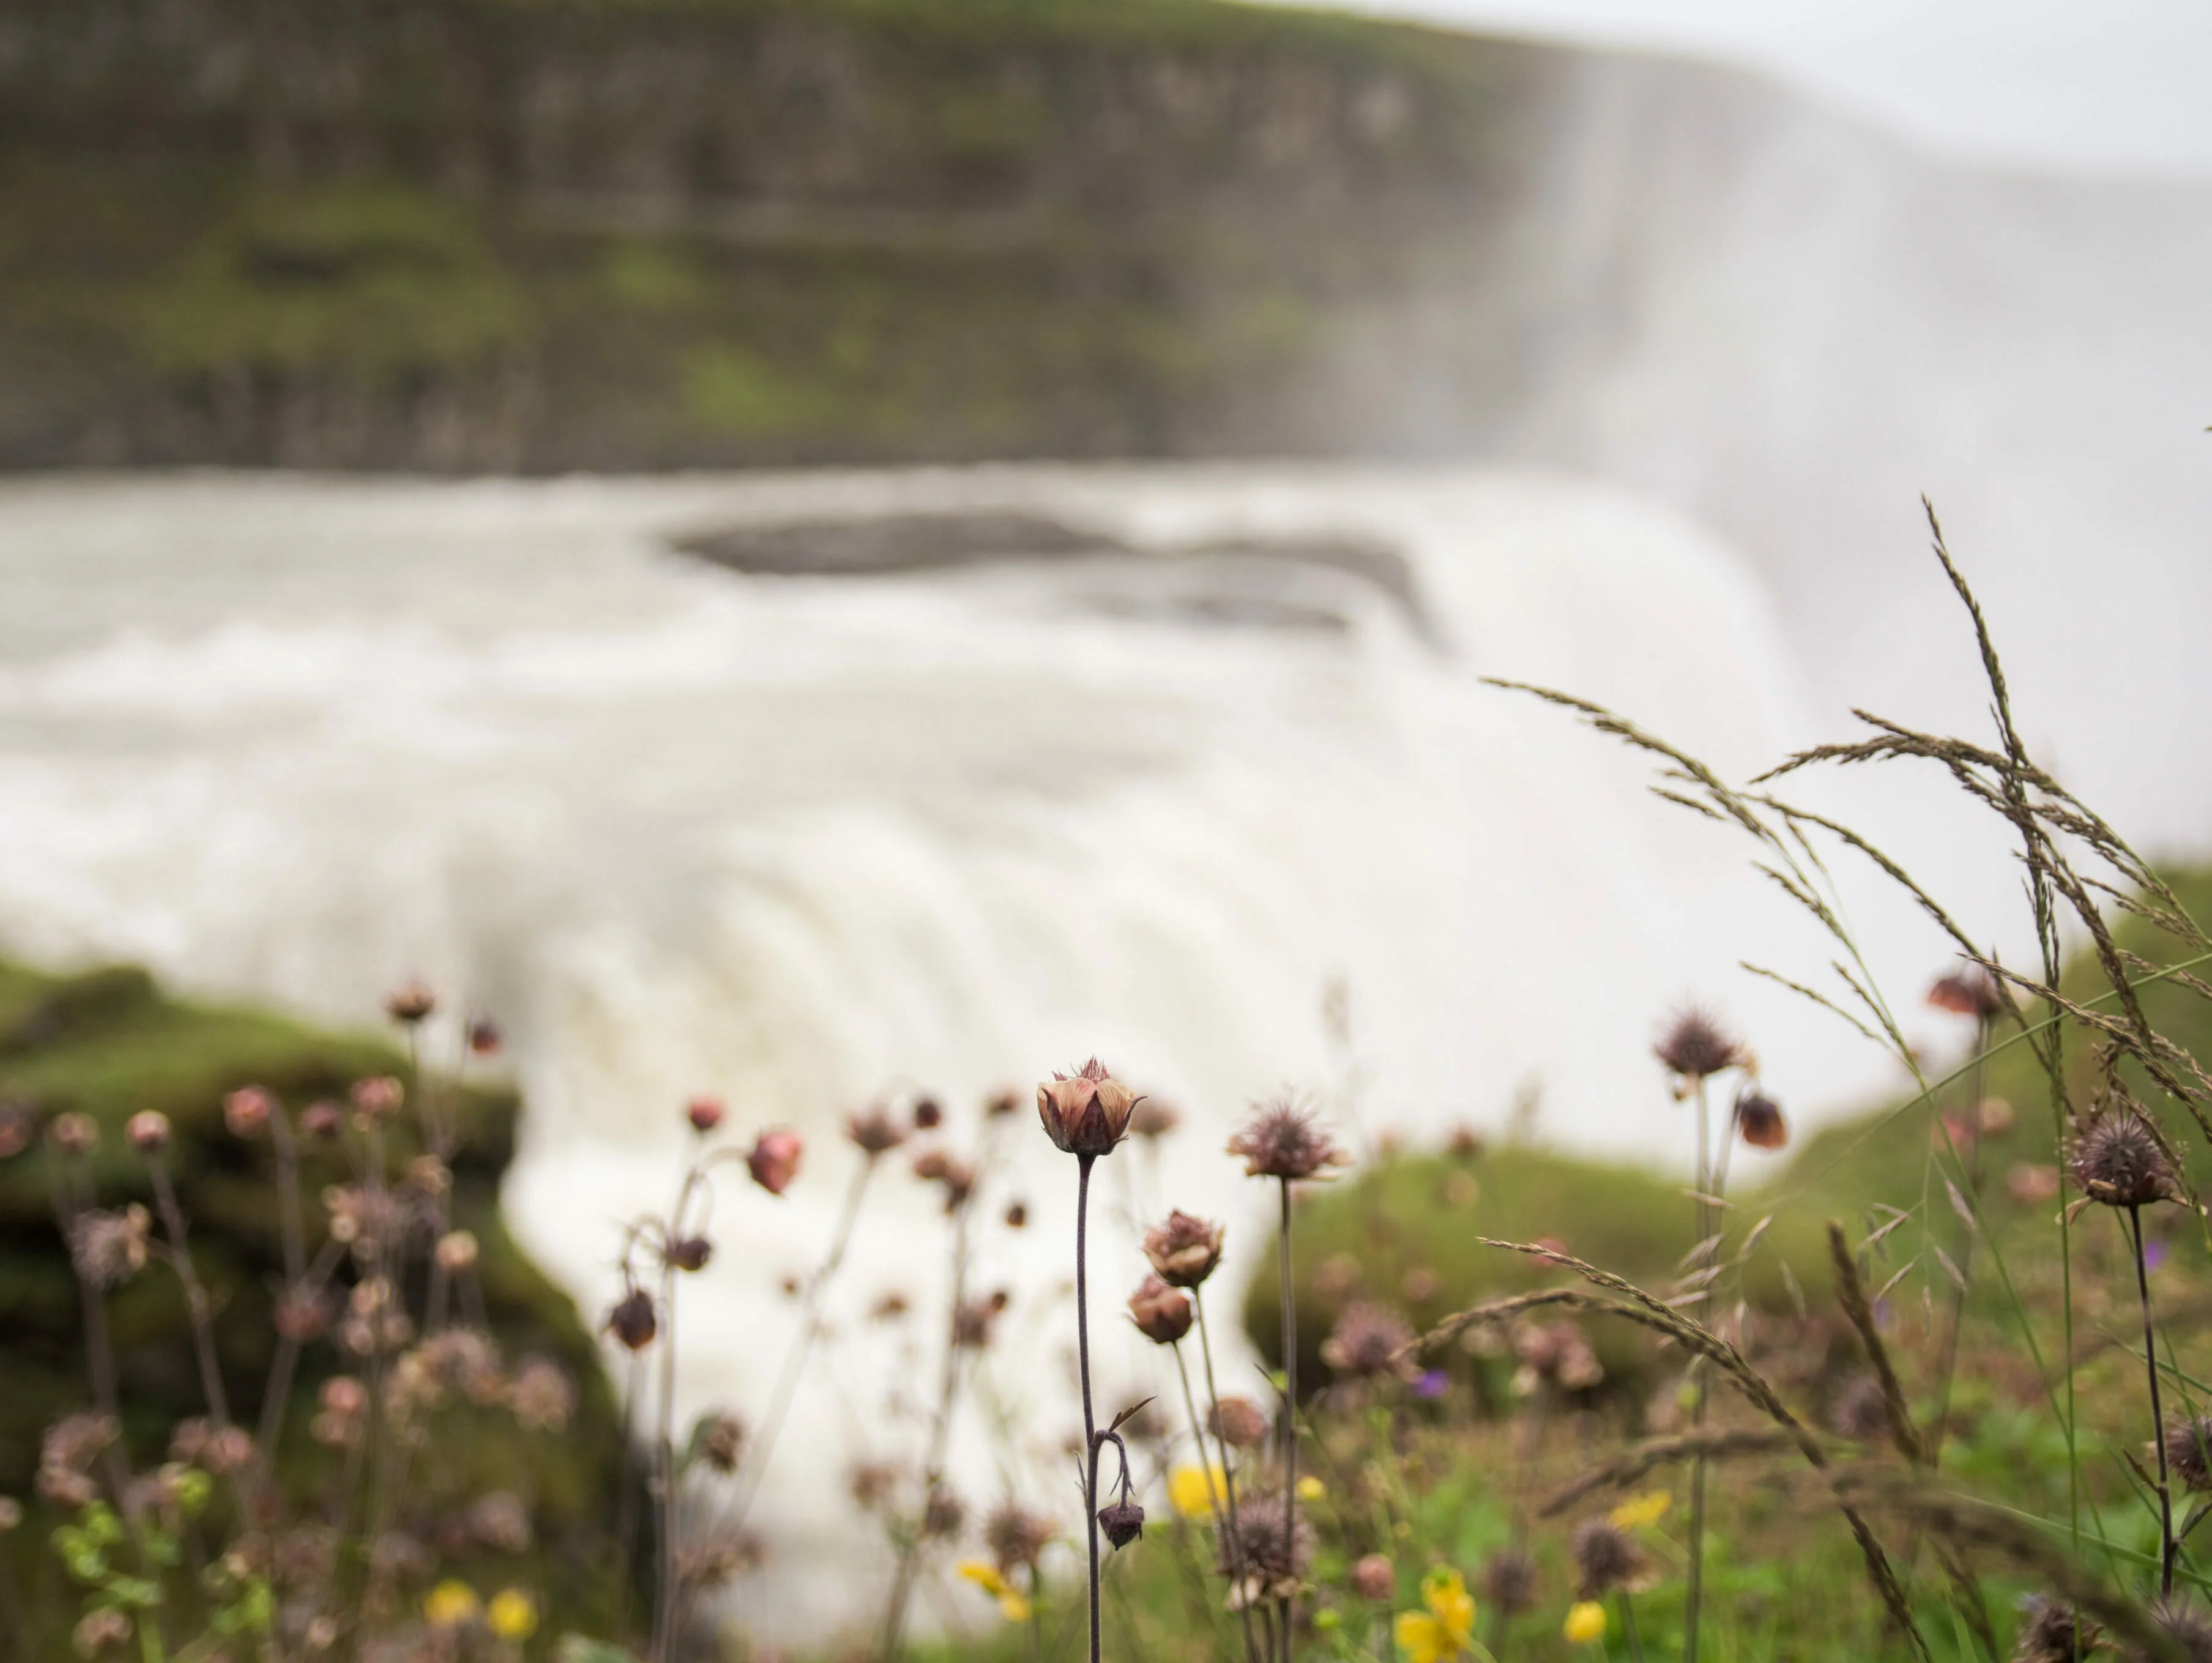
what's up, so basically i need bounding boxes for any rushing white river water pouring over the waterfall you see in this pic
[0,469,2106,1628]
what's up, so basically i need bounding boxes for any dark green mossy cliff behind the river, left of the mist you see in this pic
[0,0,1562,469]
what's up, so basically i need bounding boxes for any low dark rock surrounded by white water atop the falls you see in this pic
[675,511,1442,645]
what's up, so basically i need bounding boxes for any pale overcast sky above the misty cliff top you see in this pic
[1292,0,2212,177]
